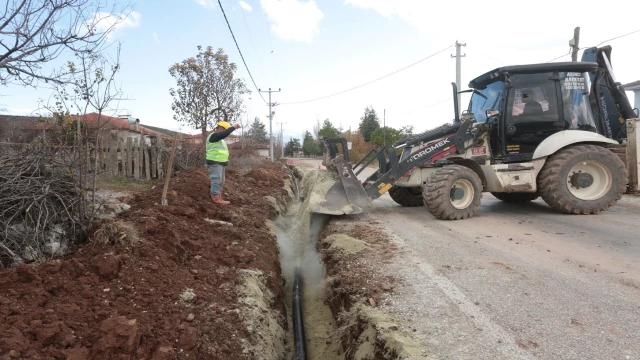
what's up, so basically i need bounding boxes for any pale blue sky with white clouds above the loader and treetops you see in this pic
[0,0,640,141]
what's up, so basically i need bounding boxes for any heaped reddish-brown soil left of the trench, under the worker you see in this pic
[0,162,288,360]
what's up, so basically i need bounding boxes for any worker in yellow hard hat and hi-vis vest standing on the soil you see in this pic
[206,121,240,205]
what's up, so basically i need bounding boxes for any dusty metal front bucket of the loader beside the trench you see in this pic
[312,158,371,215]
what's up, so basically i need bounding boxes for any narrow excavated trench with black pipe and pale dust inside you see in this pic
[275,171,345,360]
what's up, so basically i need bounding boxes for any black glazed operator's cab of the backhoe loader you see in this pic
[468,62,597,162]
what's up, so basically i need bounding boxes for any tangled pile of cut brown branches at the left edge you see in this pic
[0,146,90,267]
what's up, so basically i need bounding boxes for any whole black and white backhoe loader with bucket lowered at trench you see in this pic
[314,46,638,220]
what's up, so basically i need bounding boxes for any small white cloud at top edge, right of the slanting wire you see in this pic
[260,0,324,43]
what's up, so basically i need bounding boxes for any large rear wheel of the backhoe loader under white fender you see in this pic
[538,145,628,214]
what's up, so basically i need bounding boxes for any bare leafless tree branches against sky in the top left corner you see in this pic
[0,0,132,85]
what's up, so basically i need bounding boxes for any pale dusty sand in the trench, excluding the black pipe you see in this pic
[276,171,344,360]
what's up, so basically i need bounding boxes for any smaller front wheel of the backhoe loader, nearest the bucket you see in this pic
[422,165,482,220]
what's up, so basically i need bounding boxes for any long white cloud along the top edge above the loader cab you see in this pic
[344,0,604,49]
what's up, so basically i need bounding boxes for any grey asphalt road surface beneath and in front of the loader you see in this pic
[292,161,640,360]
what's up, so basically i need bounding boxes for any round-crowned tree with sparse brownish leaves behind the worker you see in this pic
[169,46,251,143]
